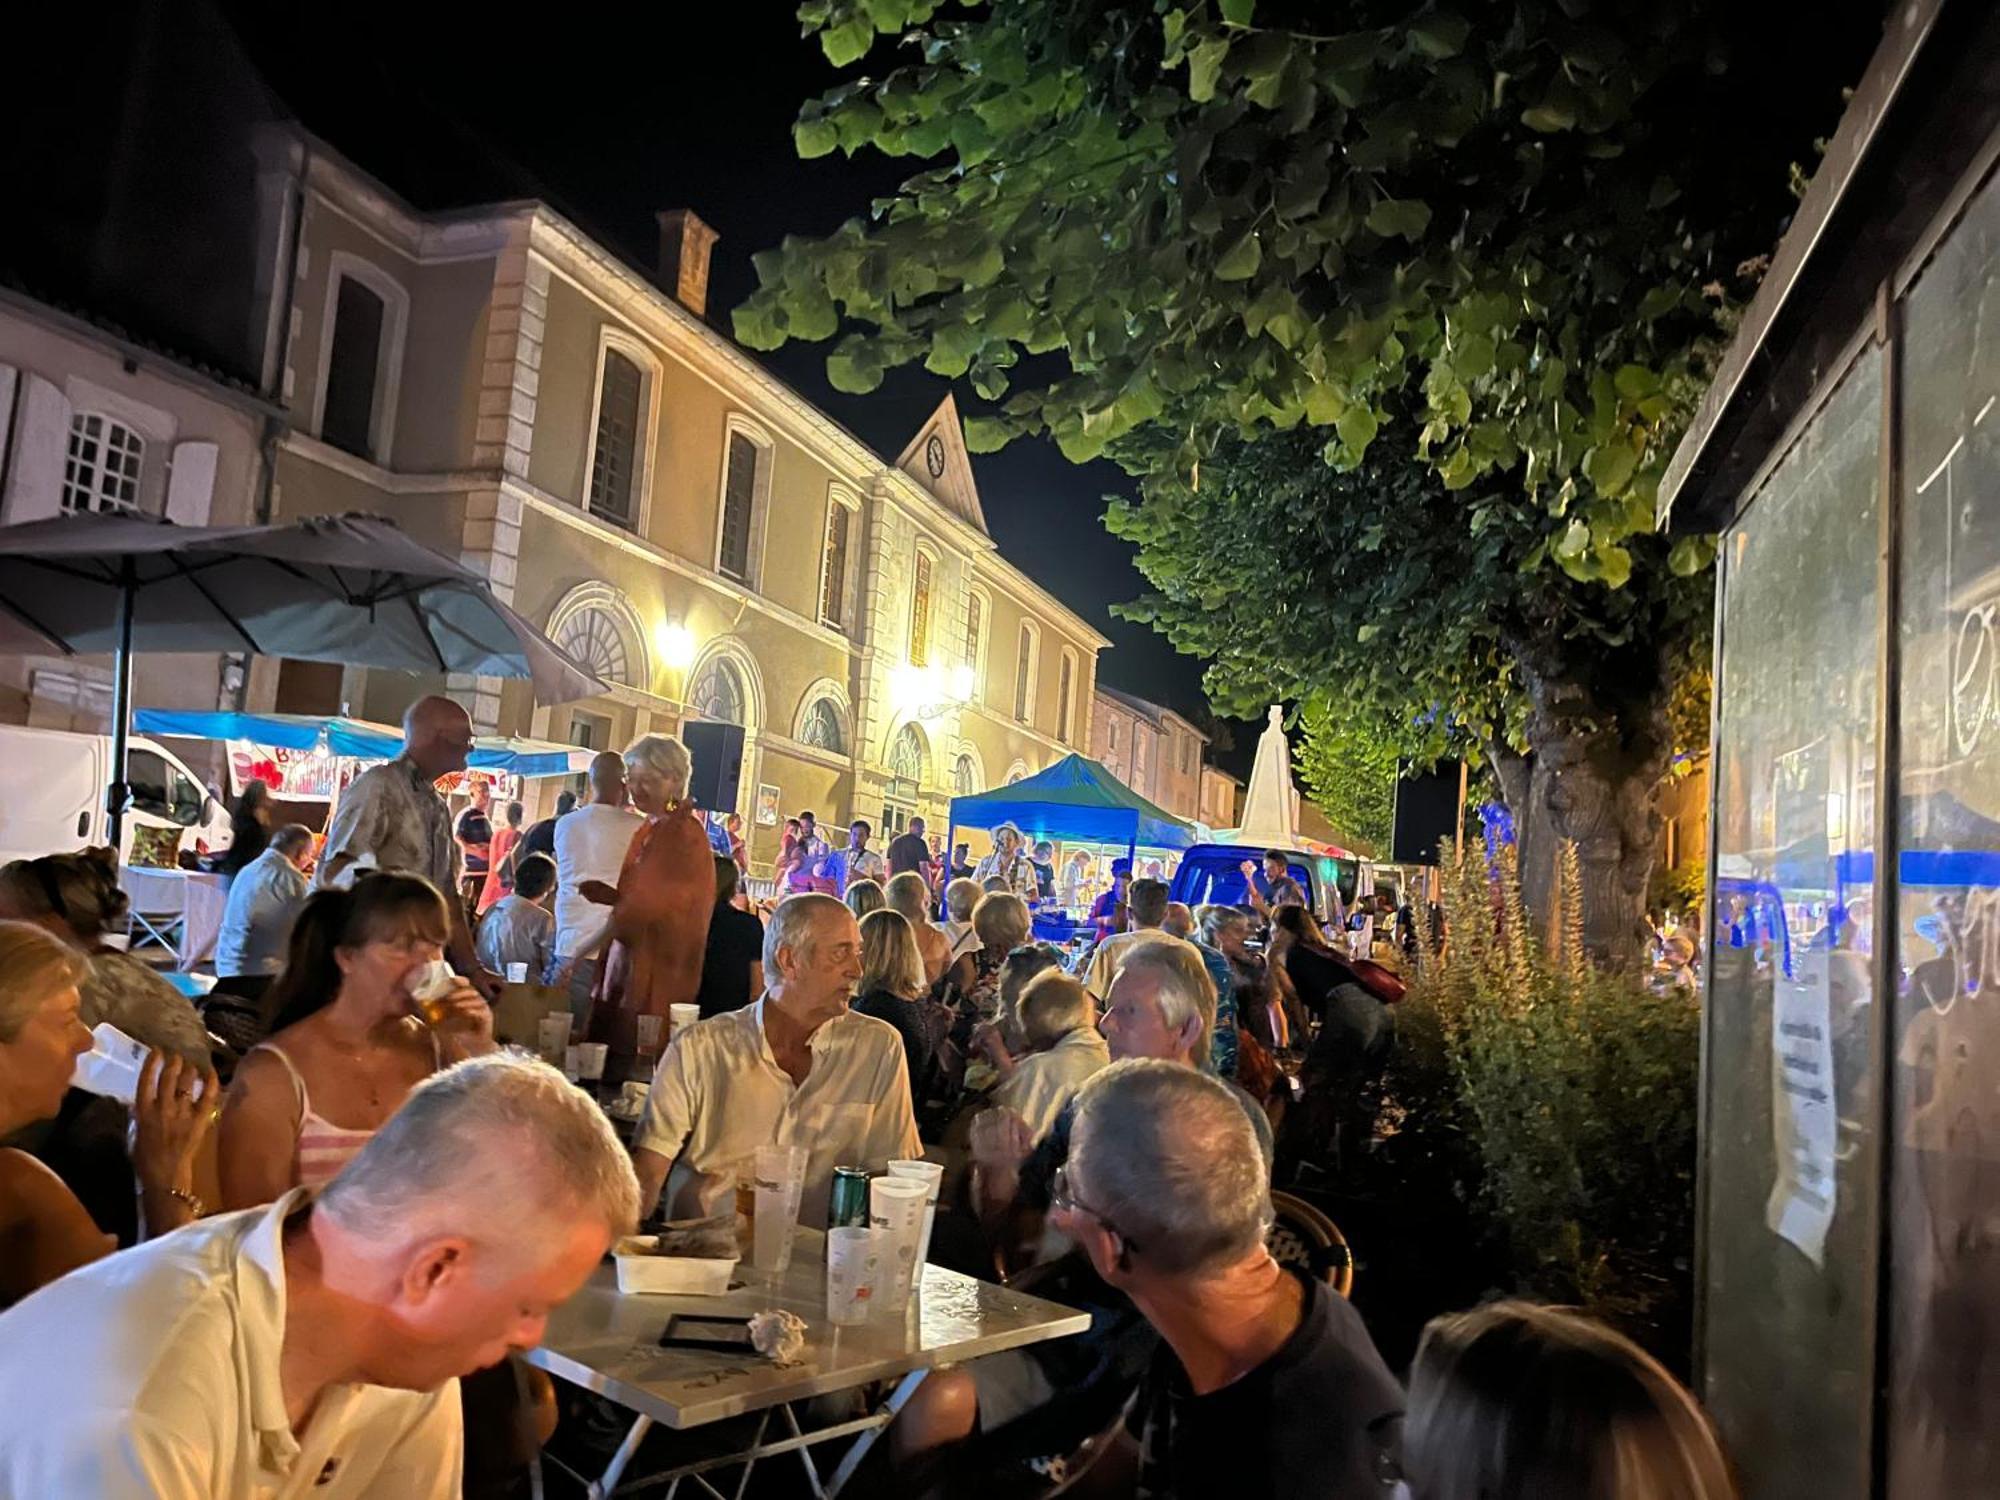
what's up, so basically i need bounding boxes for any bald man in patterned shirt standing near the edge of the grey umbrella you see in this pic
[312,696,500,1000]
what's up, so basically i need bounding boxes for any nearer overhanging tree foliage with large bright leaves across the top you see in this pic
[736,0,1838,588]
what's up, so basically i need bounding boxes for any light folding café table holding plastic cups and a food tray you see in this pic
[526,1228,1090,1500]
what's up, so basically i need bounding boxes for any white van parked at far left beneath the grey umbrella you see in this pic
[0,724,230,864]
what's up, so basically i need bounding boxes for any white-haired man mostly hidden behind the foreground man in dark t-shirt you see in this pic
[890,936,1272,1486]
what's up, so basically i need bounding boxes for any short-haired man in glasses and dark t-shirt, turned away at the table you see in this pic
[1054,1062,1404,1500]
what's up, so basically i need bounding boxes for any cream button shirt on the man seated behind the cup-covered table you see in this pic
[632,998,922,1226]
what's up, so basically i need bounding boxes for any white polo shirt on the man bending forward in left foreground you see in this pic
[0,1188,464,1500]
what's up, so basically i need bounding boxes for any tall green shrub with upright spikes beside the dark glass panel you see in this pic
[1398,850,1700,1364]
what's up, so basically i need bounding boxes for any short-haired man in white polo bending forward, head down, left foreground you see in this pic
[0,1054,638,1500]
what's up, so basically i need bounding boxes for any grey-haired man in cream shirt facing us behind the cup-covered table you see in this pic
[632,892,922,1226]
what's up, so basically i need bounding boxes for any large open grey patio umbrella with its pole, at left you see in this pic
[0,516,604,838]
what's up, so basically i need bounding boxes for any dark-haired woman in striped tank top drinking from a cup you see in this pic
[220,874,494,1208]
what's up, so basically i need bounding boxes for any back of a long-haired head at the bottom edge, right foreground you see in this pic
[1404,1302,1736,1500]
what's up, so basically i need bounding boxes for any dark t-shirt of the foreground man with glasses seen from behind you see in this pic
[1126,1280,1402,1500]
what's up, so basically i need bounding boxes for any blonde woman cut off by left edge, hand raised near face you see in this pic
[0,922,218,1308]
